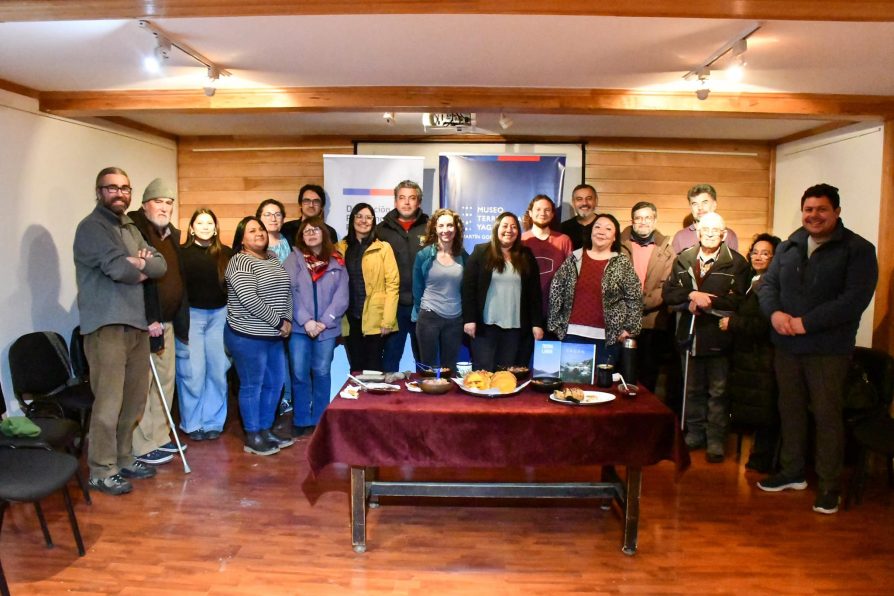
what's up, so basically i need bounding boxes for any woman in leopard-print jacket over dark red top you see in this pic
[548,213,643,364]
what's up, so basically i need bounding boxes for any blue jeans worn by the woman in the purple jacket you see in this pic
[289,332,336,426]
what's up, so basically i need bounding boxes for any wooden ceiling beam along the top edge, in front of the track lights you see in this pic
[0,0,894,21]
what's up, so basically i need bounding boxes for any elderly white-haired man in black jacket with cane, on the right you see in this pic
[662,213,750,463]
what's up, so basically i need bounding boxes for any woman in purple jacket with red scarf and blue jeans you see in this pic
[283,217,348,436]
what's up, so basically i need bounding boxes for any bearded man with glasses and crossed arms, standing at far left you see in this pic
[73,167,167,495]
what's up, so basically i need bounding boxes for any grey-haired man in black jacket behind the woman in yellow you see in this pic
[376,180,428,372]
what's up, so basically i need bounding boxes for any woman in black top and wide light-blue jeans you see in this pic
[176,208,233,441]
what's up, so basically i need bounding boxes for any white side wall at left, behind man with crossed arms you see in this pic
[0,90,177,411]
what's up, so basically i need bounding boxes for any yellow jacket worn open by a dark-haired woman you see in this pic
[335,240,400,335]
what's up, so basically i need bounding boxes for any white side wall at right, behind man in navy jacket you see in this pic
[773,124,884,346]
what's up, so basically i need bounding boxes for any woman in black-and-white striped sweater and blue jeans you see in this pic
[224,215,293,455]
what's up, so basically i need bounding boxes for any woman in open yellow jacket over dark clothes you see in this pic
[336,203,400,371]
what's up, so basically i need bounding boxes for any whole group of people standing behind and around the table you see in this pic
[74,168,877,511]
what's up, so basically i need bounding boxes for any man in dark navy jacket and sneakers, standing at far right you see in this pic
[758,184,878,513]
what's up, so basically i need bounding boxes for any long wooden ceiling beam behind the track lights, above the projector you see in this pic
[40,87,894,120]
